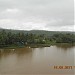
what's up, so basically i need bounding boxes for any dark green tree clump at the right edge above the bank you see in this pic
[53,34,75,43]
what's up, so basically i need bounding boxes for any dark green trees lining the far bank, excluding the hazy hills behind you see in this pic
[0,30,75,48]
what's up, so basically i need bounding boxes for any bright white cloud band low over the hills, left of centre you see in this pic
[0,19,46,30]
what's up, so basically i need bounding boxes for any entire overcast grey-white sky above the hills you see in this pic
[0,0,74,31]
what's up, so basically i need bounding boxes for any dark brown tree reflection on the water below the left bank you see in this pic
[0,47,32,56]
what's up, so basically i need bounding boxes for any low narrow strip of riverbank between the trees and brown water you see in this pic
[0,43,75,49]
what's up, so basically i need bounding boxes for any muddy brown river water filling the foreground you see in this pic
[0,45,75,75]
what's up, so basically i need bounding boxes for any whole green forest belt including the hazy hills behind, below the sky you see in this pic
[0,29,75,47]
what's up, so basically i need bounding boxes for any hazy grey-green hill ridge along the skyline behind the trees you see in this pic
[0,29,75,36]
